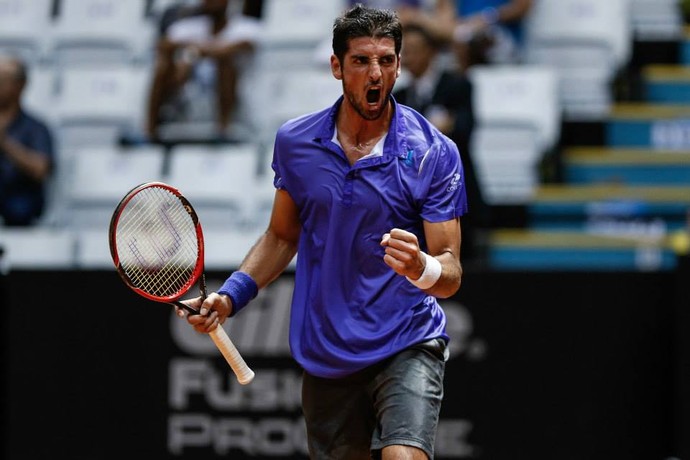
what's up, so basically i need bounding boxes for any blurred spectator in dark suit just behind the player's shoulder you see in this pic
[393,25,486,259]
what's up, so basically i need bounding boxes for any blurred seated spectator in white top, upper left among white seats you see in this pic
[146,0,262,140]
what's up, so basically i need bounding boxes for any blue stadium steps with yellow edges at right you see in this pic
[478,16,690,271]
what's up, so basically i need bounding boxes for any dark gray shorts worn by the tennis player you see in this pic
[302,339,448,460]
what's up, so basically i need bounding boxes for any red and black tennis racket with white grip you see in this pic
[109,182,254,385]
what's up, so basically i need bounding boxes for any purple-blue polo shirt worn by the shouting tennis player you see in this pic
[272,97,467,378]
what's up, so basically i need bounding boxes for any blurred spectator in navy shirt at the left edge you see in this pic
[0,55,54,226]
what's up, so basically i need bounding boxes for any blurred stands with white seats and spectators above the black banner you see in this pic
[0,0,690,270]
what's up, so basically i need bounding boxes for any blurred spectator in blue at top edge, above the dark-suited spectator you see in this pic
[401,0,533,71]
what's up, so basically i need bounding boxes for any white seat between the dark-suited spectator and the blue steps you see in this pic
[468,65,561,204]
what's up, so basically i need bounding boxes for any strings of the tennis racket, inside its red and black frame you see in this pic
[116,187,200,297]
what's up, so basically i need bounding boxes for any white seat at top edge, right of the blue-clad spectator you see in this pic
[524,0,632,120]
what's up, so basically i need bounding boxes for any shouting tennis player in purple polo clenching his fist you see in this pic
[181,5,467,460]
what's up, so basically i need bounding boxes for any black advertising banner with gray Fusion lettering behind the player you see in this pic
[2,271,688,460]
